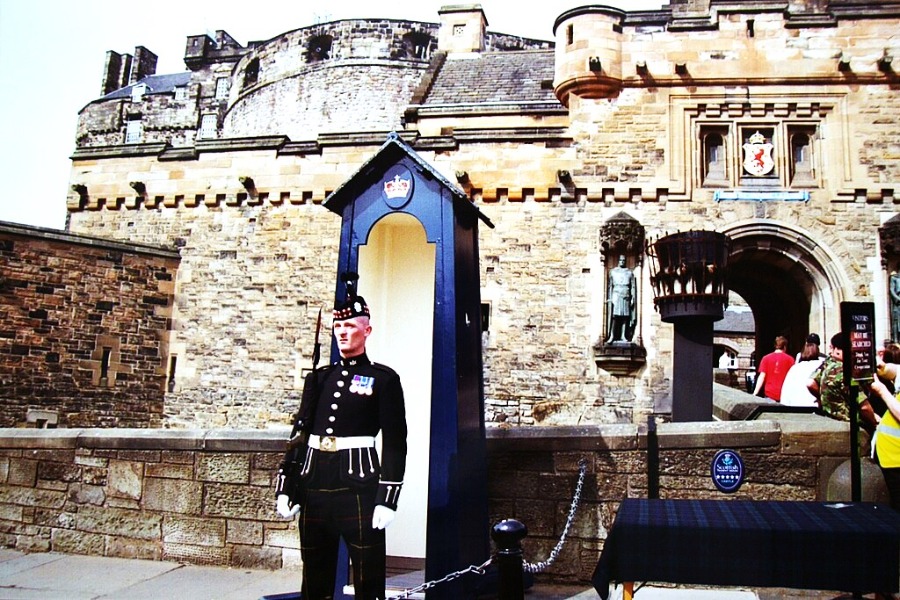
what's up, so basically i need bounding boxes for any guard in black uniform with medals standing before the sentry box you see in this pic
[276,274,406,600]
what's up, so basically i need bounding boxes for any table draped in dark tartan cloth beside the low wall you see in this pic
[592,498,900,600]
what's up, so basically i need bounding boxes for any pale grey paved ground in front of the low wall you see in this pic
[0,548,892,600]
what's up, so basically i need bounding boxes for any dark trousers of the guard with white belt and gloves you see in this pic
[299,452,386,600]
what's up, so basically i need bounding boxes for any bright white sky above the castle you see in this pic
[0,0,663,229]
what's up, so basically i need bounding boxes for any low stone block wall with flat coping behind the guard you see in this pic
[0,415,849,585]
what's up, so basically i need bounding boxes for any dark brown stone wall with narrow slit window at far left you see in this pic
[0,223,180,427]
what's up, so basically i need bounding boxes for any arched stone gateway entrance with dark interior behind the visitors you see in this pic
[722,221,849,360]
